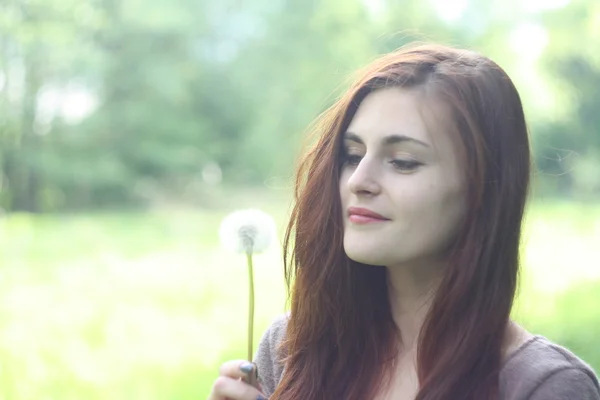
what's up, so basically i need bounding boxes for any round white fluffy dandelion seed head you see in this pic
[219,209,277,254]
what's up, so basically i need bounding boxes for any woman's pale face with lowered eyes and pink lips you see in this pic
[340,88,466,267]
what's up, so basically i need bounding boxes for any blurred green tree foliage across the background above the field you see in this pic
[0,0,600,212]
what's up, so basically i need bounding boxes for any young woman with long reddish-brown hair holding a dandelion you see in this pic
[209,45,600,400]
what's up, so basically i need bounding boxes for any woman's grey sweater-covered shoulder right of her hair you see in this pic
[500,336,600,400]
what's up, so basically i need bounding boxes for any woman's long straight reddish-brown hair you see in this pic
[272,45,530,400]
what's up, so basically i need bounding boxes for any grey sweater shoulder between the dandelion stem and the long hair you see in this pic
[254,313,289,396]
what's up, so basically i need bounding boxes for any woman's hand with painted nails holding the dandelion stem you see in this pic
[208,360,267,400]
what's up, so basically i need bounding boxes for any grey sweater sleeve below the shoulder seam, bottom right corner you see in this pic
[529,368,600,400]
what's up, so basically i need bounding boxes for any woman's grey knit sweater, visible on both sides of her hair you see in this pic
[254,315,600,400]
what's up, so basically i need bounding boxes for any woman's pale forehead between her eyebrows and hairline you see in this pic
[347,87,456,153]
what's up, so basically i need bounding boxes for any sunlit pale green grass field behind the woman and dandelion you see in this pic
[0,193,600,400]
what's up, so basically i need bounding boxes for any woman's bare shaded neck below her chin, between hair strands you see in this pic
[387,264,441,354]
